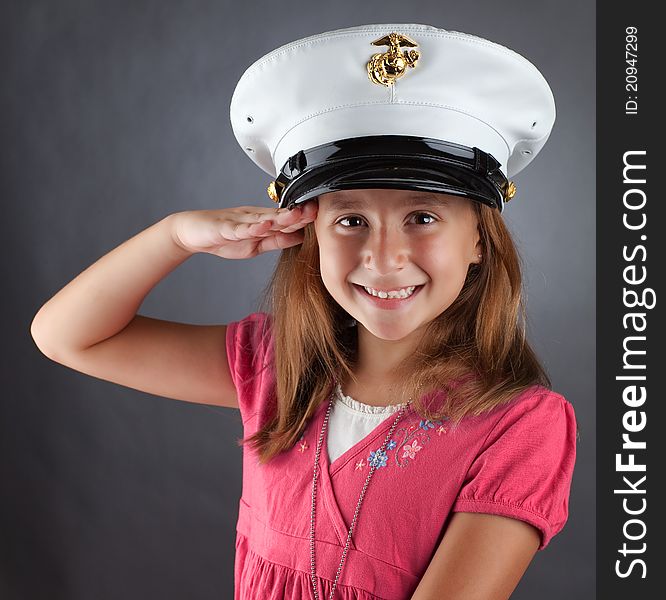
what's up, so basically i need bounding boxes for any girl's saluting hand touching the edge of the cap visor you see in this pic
[172,199,318,258]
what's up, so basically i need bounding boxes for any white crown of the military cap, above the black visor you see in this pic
[230,23,555,209]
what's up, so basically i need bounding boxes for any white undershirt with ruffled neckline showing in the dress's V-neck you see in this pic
[326,385,401,463]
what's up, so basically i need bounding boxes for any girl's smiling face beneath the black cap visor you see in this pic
[314,189,481,340]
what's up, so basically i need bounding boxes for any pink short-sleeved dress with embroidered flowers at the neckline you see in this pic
[226,313,576,600]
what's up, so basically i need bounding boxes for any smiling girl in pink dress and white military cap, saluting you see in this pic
[32,24,576,600]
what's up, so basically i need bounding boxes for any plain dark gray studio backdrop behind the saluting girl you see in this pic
[0,0,595,600]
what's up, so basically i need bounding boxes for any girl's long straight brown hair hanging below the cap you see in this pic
[240,201,550,464]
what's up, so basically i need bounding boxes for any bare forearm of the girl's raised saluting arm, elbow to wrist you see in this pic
[30,214,192,355]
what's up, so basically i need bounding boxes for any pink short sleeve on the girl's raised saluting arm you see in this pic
[226,312,272,424]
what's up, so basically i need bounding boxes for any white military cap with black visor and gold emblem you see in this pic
[230,23,555,211]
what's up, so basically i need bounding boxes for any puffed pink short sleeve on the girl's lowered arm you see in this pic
[452,388,576,550]
